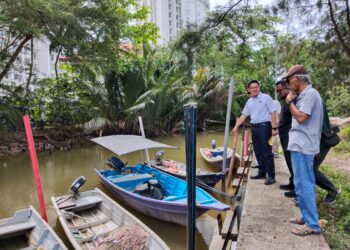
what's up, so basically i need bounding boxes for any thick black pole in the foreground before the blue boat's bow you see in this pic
[184,103,197,250]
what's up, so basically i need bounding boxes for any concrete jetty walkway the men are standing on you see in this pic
[209,156,330,250]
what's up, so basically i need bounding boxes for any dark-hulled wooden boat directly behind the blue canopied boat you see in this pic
[151,160,227,188]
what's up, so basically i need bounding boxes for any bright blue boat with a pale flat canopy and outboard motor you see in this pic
[92,135,230,225]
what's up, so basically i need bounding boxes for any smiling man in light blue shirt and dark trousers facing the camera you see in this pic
[231,80,277,185]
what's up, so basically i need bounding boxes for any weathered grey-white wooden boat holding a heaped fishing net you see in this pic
[51,188,169,250]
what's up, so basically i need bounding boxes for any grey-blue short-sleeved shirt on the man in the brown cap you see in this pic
[288,85,323,155]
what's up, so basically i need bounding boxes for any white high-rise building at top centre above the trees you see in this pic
[138,0,210,44]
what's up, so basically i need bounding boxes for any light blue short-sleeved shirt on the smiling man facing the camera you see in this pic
[242,92,276,124]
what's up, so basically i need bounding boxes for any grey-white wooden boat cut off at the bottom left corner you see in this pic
[0,206,67,250]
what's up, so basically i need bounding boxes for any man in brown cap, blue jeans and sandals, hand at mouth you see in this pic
[283,65,323,236]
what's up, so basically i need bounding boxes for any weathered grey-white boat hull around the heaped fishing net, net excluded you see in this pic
[51,188,169,250]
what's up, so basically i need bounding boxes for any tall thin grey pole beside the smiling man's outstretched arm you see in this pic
[221,78,235,192]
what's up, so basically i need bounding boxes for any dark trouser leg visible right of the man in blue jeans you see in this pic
[313,146,338,193]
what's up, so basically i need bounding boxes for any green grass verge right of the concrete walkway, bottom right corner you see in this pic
[317,165,350,249]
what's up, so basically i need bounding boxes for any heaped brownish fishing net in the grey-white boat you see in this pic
[95,225,148,250]
